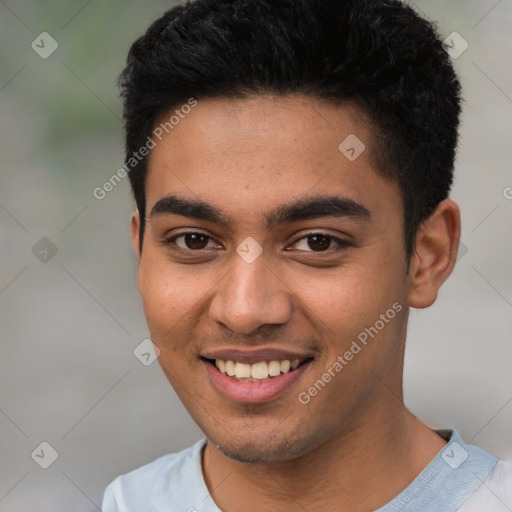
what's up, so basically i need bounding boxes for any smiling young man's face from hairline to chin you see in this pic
[132,96,407,462]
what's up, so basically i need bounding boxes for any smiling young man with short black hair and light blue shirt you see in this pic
[103,0,512,512]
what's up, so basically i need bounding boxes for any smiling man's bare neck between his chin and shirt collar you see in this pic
[202,400,446,512]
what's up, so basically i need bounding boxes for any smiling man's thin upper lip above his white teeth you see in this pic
[200,347,314,364]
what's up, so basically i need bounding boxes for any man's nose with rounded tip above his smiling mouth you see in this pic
[210,255,292,335]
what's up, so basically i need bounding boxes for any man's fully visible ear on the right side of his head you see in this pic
[408,199,460,308]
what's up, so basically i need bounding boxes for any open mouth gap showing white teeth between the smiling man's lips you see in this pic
[201,357,313,382]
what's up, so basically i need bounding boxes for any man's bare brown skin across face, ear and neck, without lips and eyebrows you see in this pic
[131,95,460,512]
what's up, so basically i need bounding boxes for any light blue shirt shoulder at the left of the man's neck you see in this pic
[102,439,206,512]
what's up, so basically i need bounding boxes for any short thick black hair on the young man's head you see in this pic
[118,0,461,258]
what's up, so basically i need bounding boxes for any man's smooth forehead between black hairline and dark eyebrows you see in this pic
[146,96,400,226]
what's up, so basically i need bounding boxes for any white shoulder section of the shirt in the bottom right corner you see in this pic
[458,460,512,512]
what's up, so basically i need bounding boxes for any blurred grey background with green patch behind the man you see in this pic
[0,0,512,512]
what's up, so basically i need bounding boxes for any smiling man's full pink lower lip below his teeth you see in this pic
[202,360,311,404]
